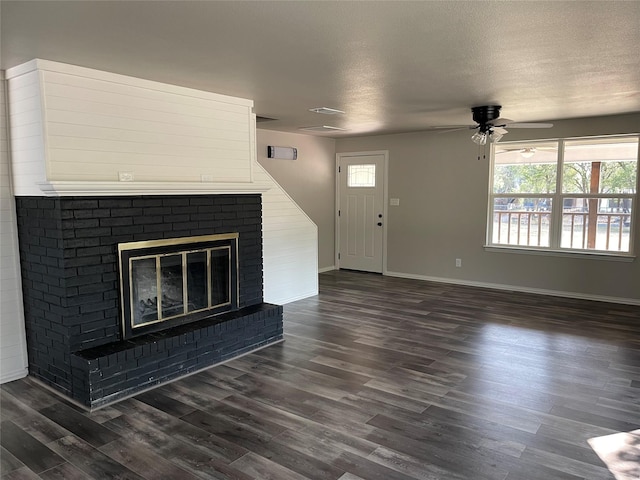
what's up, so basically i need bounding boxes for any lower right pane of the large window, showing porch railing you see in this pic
[561,197,633,252]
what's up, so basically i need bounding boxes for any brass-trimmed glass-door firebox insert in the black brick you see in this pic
[118,233,238,338]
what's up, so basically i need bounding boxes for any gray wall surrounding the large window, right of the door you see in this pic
[336,113,640,301]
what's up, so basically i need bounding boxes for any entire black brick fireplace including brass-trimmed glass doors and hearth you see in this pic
[16,194,283,409]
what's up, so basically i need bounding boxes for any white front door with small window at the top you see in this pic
[337,152,386,273]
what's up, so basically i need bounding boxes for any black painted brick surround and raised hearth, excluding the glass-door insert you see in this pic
[16,194,282,408]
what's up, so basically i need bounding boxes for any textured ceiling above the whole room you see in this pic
[0,0,640,137]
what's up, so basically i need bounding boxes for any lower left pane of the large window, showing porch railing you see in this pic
[492,198,551,247]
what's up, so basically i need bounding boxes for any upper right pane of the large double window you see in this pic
[562,137,638,193]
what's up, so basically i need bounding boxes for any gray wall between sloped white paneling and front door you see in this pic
[256,129,336,270]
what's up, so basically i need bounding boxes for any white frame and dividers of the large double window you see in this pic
[484,134,640,261]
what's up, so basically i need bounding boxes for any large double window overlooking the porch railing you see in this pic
[487,135,638,255]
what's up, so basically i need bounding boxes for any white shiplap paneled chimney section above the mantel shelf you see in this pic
[7,60,253,195]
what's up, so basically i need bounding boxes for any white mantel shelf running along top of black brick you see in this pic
[37,181,269,197]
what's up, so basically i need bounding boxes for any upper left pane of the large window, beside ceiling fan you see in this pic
[493,142,558,194]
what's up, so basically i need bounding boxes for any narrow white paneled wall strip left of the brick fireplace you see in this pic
[0,75,27,383]
